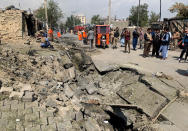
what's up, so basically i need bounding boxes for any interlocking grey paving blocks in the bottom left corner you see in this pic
[0,100,63,131]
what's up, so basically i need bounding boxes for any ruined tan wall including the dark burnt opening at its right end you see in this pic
[0,10,42,41]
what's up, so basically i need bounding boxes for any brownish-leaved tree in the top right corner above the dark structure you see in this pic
[169,2,188,18]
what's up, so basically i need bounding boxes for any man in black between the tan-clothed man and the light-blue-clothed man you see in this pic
[152,29,161,58]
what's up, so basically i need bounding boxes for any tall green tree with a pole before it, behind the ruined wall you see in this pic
[34,0,63,28]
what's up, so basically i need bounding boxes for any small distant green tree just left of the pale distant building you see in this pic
[65,15,81,30]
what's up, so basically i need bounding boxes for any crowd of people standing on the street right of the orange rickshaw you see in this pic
[113,27,188,61]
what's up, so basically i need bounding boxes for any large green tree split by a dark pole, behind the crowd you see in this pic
[129,3,148,27]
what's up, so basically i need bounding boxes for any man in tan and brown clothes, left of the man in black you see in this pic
[143,28,153,57]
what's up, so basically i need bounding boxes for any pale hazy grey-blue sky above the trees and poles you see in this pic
[0,0,188,21]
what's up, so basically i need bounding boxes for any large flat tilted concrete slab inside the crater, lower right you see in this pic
[117,83,167,117]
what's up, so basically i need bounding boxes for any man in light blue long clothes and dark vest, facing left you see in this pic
[159,27,170,60]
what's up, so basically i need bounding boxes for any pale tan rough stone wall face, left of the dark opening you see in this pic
[0,10,23,41]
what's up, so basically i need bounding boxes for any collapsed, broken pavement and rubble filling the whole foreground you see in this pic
[0,35,188,131]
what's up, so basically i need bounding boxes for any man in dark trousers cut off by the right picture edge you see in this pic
[179,29,188,62]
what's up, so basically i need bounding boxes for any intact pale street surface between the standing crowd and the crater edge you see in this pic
[92,44,188,88]
